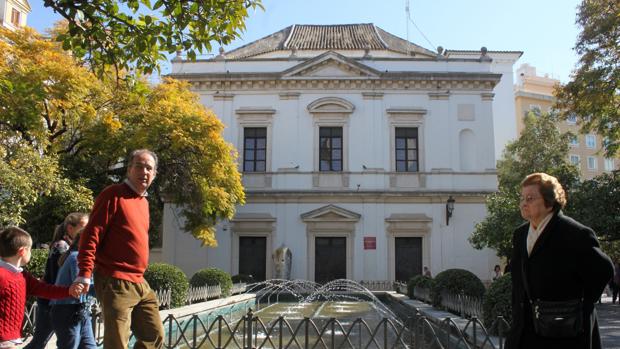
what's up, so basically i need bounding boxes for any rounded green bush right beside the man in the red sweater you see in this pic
[144,263,189,308]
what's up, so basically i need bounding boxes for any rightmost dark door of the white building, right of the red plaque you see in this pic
[394,237,422,282]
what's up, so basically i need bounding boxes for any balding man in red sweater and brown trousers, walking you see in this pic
[74,149,164,349]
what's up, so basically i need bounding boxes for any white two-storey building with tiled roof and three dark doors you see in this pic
[162,24,520,282]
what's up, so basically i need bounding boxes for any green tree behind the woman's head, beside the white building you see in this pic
[469,113,579,257]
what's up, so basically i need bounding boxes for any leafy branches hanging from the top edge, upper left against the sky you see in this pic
[44,0,262,73]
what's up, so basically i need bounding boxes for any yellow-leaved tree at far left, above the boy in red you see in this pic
[0,29,98,241]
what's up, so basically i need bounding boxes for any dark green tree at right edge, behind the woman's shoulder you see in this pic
[567,171,620,258]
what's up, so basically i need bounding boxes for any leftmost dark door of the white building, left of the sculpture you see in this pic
[239,236,267,281]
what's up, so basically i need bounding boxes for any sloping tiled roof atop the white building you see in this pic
[225,23,436,59]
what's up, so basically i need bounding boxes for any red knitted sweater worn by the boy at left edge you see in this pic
[0,268,70,342]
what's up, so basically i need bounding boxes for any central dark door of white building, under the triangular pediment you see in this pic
[314,237,347,284]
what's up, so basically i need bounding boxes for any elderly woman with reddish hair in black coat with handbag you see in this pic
[506,173,613,349]
